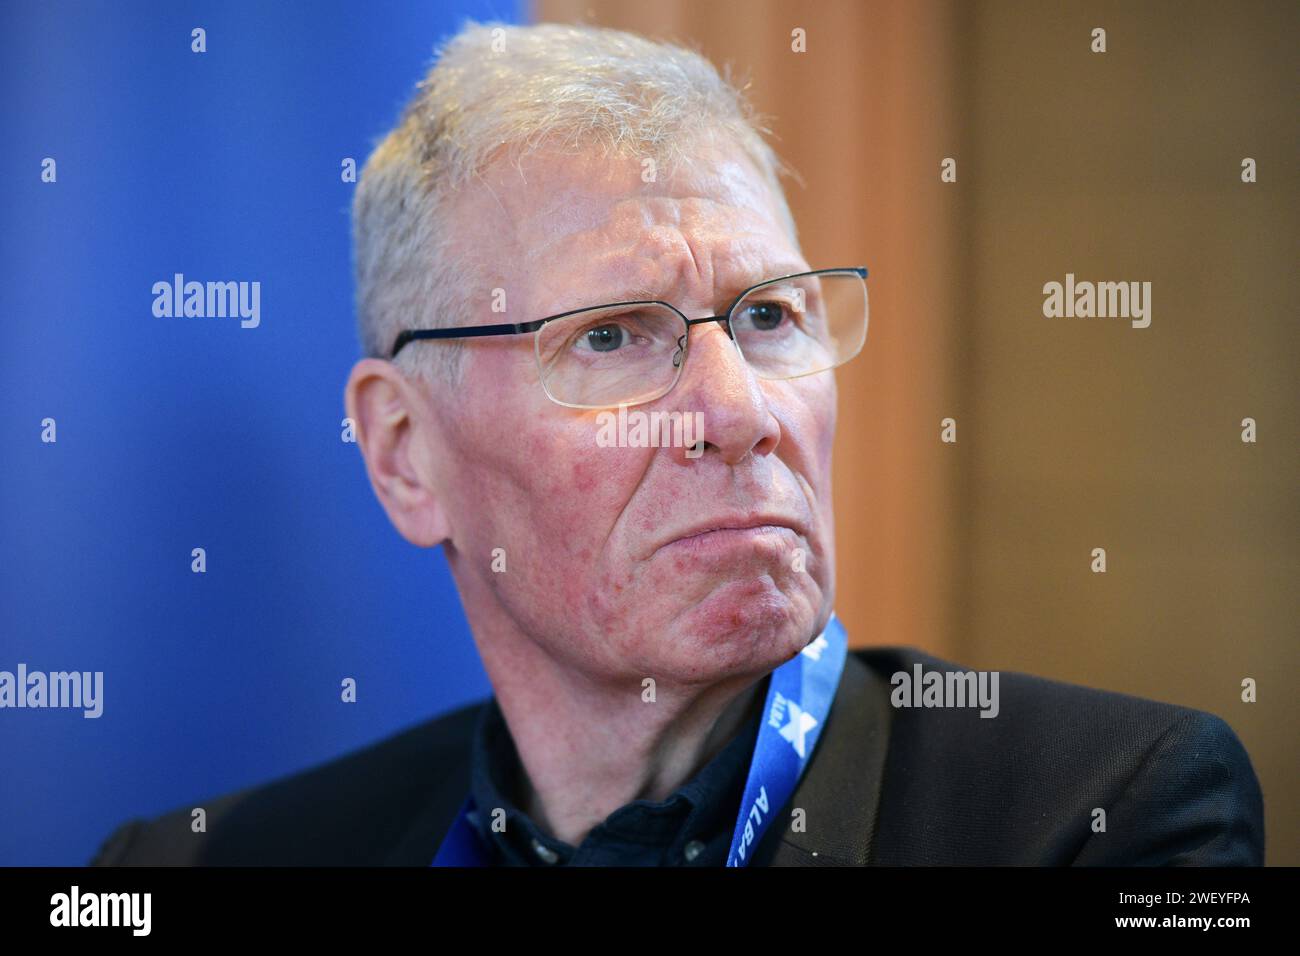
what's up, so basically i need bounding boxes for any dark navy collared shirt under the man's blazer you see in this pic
[469,696,759,866]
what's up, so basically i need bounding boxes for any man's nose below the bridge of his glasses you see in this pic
[667,323,781,466]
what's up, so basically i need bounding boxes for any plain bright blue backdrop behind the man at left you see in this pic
[0,0,523,865]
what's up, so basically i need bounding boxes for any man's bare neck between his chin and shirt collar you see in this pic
[476,621,764,845]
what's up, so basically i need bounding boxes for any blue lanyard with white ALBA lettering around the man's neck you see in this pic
[430,614,849,866]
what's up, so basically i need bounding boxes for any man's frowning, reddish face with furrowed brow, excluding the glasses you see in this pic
[419,141,836,685]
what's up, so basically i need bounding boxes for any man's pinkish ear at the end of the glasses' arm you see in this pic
[343,359,451,548]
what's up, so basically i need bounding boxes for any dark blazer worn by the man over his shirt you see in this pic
[91,648,1264,866]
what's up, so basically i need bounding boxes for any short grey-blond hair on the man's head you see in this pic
[352,22,796,381]
